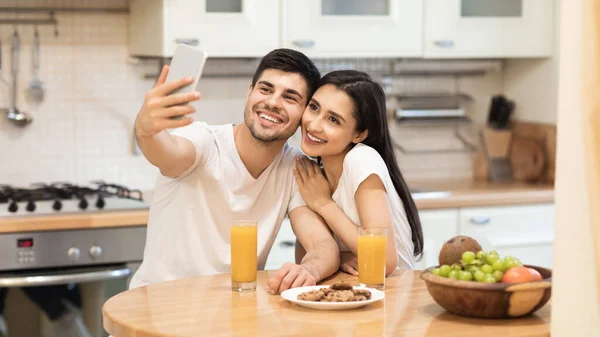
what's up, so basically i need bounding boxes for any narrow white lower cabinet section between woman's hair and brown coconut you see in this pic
[415,209,458,270]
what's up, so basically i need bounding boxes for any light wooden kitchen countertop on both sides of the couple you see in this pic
[0,180,554,233]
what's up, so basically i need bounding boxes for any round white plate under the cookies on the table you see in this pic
[281,286,385,310]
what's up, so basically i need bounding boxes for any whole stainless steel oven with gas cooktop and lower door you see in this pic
[0,183,149,337]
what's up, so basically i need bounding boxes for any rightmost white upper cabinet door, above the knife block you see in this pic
[424,0,554,58]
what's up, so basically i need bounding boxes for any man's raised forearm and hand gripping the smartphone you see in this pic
[135,66,200,177]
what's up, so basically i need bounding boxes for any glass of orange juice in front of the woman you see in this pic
[357,227,387,289]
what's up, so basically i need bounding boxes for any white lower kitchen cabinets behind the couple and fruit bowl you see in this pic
[265,204,554,270]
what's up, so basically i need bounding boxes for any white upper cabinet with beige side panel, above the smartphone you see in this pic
[129,0,280,57]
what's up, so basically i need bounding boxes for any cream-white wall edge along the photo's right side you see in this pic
[552,1,600,337]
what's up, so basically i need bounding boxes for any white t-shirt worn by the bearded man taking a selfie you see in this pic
[130,122,305,288]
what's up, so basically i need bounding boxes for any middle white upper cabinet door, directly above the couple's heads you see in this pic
[282,0,423,57]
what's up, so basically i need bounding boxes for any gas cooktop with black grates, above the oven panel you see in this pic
[0,181,150,217]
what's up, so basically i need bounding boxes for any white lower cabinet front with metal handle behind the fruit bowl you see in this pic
[459,204,554,268]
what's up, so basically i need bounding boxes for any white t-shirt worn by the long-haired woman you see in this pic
[332,144,415,269]
